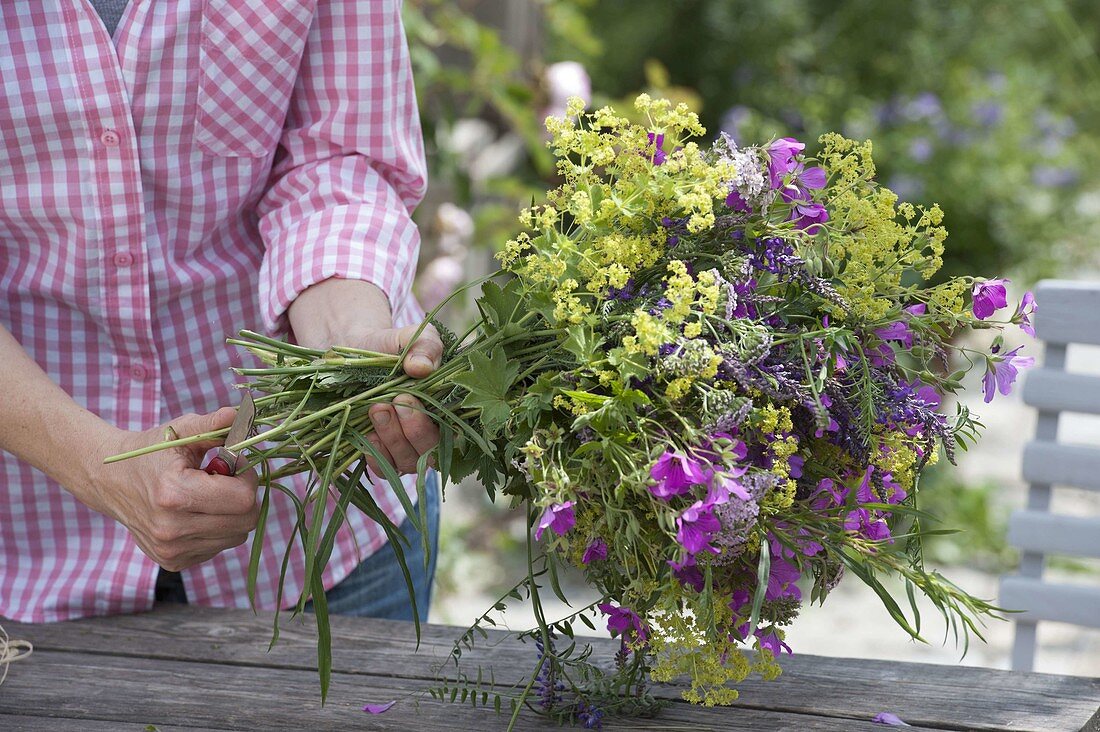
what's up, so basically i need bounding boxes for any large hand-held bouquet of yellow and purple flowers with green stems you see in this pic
[111,95,1035,726]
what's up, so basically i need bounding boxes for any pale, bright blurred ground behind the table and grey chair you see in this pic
[422,314,1100,676]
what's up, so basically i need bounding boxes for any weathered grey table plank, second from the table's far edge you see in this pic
[0,652,926,732]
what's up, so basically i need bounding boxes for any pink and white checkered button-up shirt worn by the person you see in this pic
[0,0,426,622]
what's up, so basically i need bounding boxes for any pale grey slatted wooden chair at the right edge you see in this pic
[999,280,1100,671]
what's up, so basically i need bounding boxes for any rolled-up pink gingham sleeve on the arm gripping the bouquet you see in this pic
[257,0,427,330]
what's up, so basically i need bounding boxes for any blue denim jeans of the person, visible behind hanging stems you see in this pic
[306,470,440,623]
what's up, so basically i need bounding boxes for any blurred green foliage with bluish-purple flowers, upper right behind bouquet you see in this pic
[550,0,1100,280]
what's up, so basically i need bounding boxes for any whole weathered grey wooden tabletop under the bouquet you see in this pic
[0,607,1100,732]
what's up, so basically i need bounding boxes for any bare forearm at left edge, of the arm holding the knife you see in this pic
[0,327,114,498]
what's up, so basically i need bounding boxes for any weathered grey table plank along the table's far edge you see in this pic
[6,608,1100,732]
